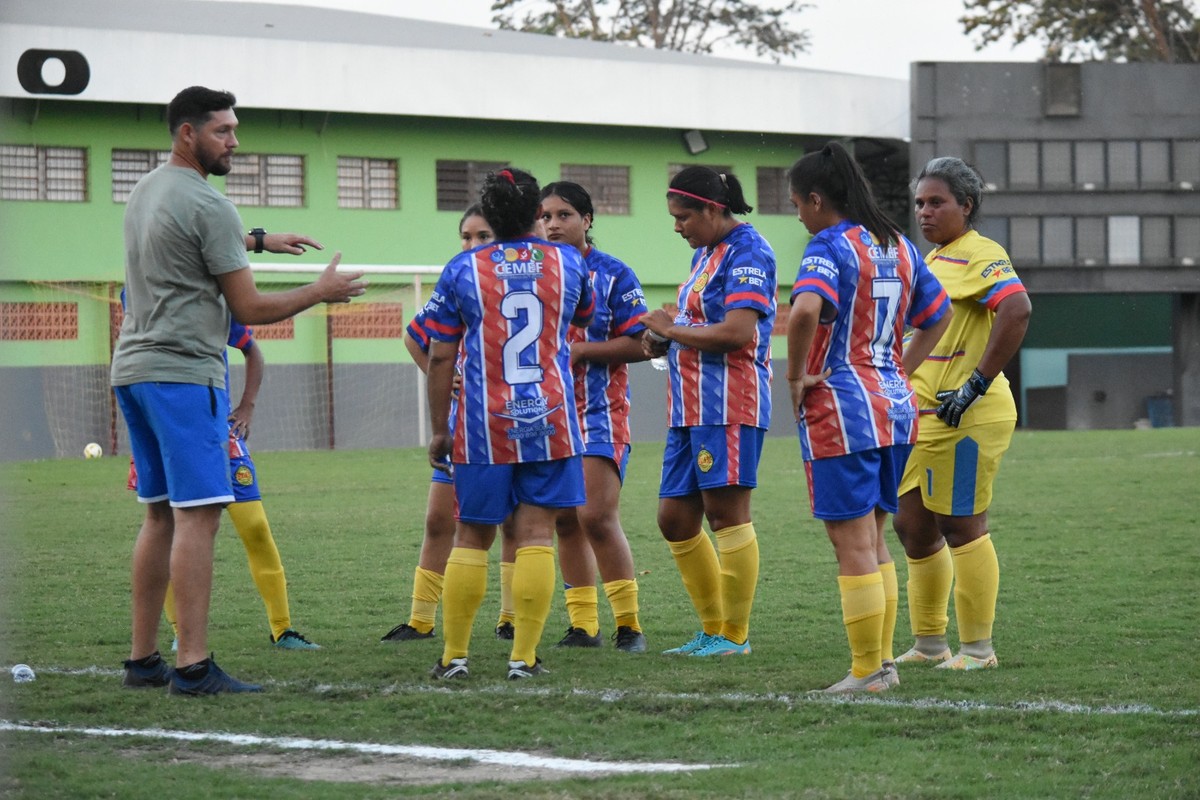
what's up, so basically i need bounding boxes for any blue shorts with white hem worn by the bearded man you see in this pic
[113,383,234,509]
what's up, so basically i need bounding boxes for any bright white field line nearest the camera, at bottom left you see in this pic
[0,720,710,775]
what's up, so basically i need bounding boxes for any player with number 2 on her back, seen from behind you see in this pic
[426,168,593,679]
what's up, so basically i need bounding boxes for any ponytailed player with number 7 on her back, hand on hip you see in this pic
[787,143,949,693]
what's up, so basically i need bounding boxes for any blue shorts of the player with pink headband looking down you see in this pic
[659,425,766,498]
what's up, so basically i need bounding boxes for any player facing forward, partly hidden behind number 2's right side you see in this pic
[541,181,646,652]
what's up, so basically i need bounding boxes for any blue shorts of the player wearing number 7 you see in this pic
[804,445,912,519]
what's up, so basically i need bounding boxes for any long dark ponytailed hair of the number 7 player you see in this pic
[787,142,900,245]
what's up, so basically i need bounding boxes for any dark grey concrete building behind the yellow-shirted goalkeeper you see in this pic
[912,62,1200,428]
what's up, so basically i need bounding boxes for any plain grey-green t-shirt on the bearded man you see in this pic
[112,164,248,389]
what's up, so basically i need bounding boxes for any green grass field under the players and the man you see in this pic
[0,428,1200,800]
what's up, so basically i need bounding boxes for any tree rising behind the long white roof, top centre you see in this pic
[492,0,811,64]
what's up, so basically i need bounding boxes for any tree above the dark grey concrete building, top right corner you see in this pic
[959,0,1200,64]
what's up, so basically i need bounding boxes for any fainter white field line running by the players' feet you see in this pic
[16,667,1200,719]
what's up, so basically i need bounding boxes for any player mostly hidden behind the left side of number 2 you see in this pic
[380,203,514,642]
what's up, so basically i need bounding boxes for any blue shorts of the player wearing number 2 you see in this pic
[454,456,587,525]
